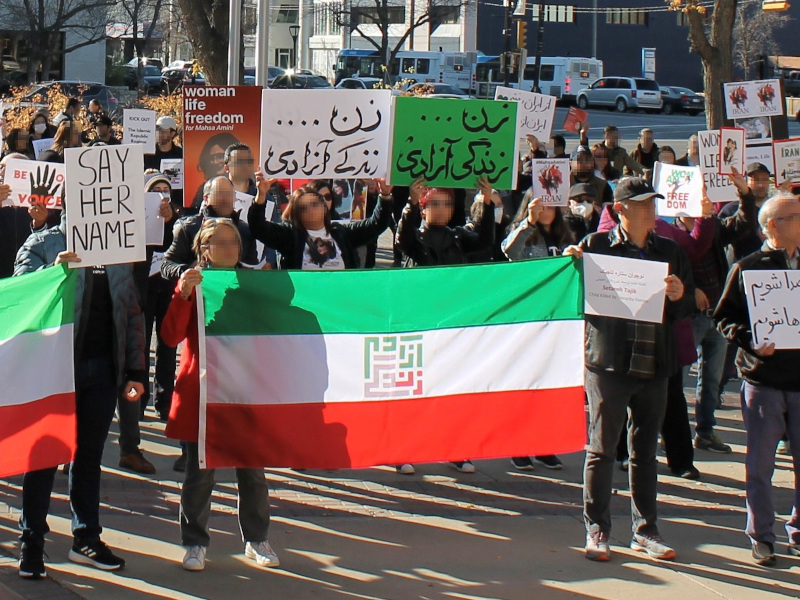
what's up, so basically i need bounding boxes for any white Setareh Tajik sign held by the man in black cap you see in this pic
[583,253,669,323]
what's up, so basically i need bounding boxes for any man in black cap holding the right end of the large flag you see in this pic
[564,177,694,561]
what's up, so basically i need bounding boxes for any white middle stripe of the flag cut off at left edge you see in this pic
[0,323,75,406]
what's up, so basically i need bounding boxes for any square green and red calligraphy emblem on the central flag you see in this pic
[364,334,422,398]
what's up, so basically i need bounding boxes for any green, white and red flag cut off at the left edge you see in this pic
[0,267,77,477]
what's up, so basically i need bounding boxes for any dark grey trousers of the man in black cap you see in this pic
[583,369,667,535]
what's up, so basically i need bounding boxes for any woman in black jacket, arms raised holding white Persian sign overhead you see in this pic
[247,173,392,270]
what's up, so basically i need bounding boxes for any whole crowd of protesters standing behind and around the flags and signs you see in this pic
[0,100,800,578]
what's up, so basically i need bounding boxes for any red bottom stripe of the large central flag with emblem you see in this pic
[206,387,586,469]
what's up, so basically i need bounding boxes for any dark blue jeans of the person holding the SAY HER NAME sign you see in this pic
[19,357,117,542]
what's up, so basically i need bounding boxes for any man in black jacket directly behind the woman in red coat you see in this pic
[161,175,258,282]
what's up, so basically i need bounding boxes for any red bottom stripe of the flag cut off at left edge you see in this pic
[0,392,76,477]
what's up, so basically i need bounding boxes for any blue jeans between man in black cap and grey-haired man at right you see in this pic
[692,313,728,436]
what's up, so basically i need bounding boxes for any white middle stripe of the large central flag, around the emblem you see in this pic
[206,320,583,404]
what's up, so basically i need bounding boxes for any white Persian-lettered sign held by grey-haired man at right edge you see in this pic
[742,270,800,350]
